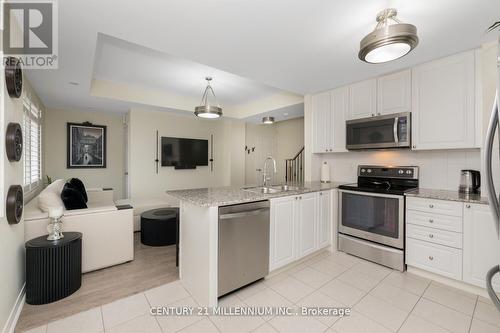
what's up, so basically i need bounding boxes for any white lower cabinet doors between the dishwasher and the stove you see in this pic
[269,190,332,271]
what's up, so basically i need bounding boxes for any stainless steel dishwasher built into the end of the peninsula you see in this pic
[218,201,270,296]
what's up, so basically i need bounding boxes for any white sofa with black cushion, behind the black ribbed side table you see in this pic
[24,184,134,273]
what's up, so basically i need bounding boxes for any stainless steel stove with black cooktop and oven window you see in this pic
[338,165,418,271]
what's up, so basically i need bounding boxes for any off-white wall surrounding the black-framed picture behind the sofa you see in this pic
[43,109,124,199]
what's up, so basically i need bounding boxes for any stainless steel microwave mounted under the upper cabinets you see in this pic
[346,112,411,150]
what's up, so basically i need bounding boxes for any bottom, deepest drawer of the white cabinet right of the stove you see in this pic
[406,237,462,280]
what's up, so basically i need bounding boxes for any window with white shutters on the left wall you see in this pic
[23,96,42,194]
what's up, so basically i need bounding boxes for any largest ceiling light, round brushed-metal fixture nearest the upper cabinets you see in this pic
[358,8,418,64]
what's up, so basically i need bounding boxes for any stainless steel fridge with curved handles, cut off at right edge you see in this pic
[483,37,500,311]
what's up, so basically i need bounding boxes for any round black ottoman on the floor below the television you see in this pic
[141,208,179,246]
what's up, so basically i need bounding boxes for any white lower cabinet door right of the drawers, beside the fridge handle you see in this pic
[463,204,500,290]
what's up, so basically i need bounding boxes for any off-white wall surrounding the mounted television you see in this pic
[128,109,245,198]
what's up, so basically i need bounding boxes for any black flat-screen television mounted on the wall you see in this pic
[161,137,208,169]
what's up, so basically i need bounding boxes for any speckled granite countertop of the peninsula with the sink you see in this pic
[167,182,346,207]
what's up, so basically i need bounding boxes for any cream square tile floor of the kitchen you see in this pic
[21,253,500,333]
